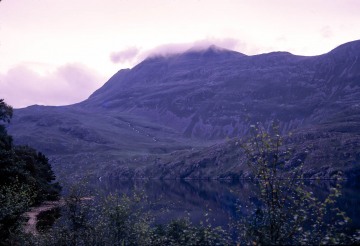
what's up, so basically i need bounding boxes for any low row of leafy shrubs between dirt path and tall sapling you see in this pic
[29,184,230,245]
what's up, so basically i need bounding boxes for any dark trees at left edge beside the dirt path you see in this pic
[0,99,61,245]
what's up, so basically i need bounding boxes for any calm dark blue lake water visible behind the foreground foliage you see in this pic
[88,180,360,231]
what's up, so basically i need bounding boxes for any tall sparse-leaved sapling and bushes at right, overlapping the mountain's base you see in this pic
[237,125,356,245]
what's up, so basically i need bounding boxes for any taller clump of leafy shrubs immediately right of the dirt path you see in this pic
[31,184,151,245]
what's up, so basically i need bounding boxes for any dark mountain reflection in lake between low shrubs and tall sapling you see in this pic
[96,180,248,226]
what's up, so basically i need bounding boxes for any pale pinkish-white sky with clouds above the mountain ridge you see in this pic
[0,0,360,108]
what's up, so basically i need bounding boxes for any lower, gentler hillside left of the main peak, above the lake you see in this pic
[9,106,201,179]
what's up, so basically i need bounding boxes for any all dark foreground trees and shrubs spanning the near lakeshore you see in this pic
[0,100,359,245]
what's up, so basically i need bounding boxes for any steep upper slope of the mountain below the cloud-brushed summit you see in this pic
[80,41,360,139]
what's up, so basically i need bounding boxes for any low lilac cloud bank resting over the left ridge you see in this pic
[0,64,104,108]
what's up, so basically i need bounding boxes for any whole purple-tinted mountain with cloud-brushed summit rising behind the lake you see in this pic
[9,41,360,183]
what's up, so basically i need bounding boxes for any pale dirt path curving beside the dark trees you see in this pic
[24,199,65,235]
